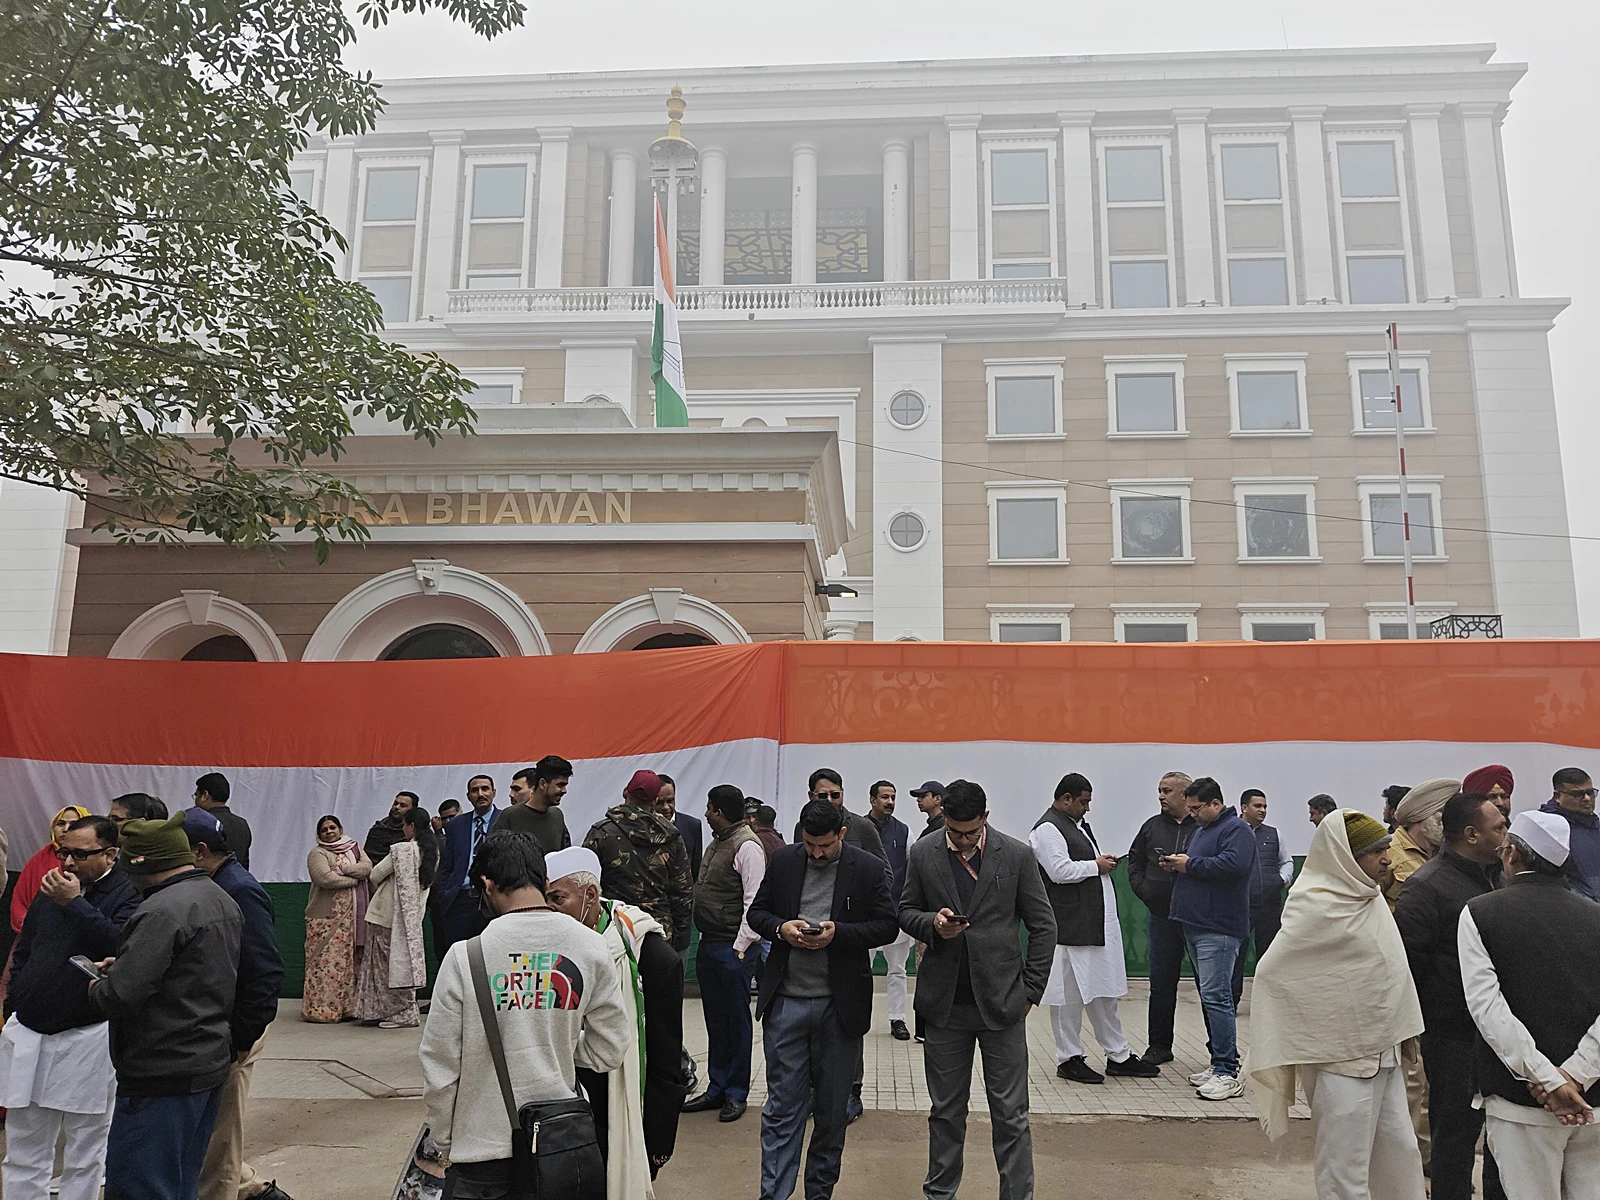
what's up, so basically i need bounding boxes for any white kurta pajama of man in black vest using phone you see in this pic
[1027,822,1130,1062]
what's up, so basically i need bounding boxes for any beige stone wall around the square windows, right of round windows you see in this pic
[944,338,1494,642]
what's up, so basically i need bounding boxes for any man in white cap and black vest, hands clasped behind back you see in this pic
[1456,813,1600,1200]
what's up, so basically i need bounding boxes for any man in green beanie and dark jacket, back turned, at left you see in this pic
[90,811,245,1200]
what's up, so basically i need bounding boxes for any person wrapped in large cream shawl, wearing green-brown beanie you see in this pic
[1243,810,1426,1200]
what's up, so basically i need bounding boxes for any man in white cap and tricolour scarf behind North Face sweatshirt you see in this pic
[544,846,688,1200]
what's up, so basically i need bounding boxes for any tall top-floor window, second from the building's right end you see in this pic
[1216,133,1294,306]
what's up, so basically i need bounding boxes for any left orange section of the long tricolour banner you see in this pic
[0,645,782,768]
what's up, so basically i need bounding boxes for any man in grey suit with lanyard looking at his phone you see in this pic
[899,779,1056,1200]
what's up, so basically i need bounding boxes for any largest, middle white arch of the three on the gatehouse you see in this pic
[301,558,550,662]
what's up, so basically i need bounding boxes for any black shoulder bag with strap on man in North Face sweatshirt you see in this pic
[467,938,605,1200]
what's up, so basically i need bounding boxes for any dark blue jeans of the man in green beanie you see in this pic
[106,1085,222,1200]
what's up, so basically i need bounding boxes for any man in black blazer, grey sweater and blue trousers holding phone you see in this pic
[747,800,902,1200]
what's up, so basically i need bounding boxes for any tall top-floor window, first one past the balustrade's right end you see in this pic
[1099,138,1173,309]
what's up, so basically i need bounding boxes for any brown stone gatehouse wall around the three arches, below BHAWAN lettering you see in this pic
[69,542,822,661]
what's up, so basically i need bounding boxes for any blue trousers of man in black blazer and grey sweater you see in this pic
[762,995,861,1200]
